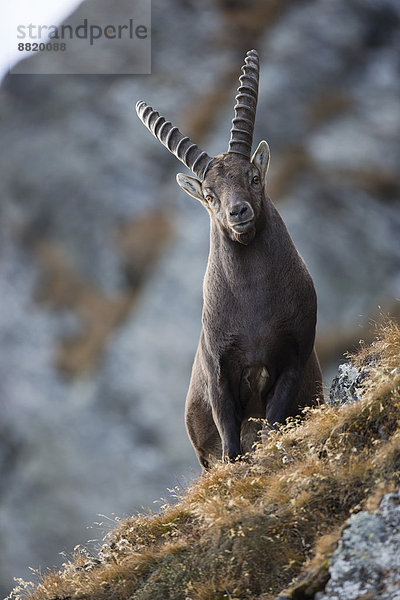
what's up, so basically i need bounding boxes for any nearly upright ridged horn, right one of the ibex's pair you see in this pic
[228,50,259,159]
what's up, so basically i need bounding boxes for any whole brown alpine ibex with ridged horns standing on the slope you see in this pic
[136,50,322,469]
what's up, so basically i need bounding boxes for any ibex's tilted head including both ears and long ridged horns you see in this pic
[136,50,269,245]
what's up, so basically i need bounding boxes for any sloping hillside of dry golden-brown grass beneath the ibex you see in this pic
[12,322,400,600]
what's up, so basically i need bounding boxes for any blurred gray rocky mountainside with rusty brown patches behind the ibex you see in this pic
[0,0,400,593]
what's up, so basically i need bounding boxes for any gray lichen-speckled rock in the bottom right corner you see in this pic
[315,490,400,600]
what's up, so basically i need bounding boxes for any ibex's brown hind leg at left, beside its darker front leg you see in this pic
[185,384,222,471]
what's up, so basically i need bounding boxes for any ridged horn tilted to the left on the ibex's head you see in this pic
[136,101,213,181]
